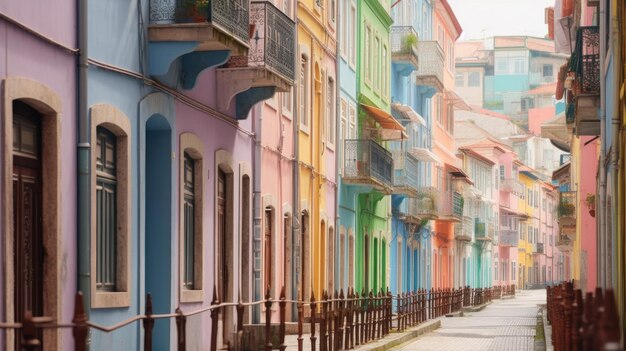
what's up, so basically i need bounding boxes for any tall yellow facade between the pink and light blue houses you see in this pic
[296,0,337,300]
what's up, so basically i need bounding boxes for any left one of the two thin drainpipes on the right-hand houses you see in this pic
[596,1,606,288]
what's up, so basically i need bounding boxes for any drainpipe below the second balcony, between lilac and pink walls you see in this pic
[252,104,263,324]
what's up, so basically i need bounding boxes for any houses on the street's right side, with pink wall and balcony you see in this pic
[541,0,626,344]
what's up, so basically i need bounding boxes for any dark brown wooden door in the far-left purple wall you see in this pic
[13,102,44,349]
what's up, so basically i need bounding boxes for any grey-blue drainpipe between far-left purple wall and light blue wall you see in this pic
[76,0,92,324]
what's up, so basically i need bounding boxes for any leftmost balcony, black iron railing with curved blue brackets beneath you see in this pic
[148,0,250,80]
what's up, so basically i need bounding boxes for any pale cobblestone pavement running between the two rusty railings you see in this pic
[396,289,546,351]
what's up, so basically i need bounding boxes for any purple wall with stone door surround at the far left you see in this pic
[0,1,77,350]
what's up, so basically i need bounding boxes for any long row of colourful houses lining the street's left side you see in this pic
[0,0,567,350]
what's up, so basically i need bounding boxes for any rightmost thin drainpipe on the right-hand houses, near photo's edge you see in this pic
[606,0,622,287]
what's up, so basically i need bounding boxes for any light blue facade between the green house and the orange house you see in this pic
[390,0,435,294]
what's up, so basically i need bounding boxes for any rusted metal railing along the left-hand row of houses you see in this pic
[0,286,515,351]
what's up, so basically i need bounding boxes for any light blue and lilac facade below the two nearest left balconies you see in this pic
[87,0,260,350]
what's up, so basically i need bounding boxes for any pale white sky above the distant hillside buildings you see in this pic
[448,0,554,40]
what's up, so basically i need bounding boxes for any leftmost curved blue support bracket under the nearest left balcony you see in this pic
[148,41,200,76]
